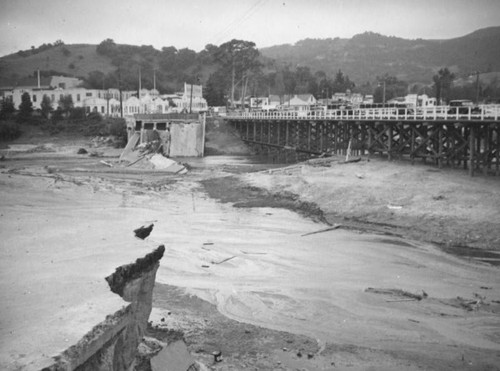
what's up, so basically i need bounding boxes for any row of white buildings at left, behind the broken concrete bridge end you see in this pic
[0,76,208,117]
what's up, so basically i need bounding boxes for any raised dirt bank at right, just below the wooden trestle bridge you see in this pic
[203,158,500,258]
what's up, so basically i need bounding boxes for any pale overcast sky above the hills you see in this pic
[0,0,500,56]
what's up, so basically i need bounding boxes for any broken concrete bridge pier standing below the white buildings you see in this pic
[126,113,205,157]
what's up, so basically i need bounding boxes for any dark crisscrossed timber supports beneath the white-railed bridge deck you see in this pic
[226,117,500,176]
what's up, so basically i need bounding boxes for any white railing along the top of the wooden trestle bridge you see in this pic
[227,104,500,121]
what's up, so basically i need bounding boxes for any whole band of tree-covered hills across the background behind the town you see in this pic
[0,27,500,105]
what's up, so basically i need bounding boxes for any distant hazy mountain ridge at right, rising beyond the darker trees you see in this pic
[260,26,500,84]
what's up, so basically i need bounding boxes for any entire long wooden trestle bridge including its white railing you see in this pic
[225,105,500,176]
